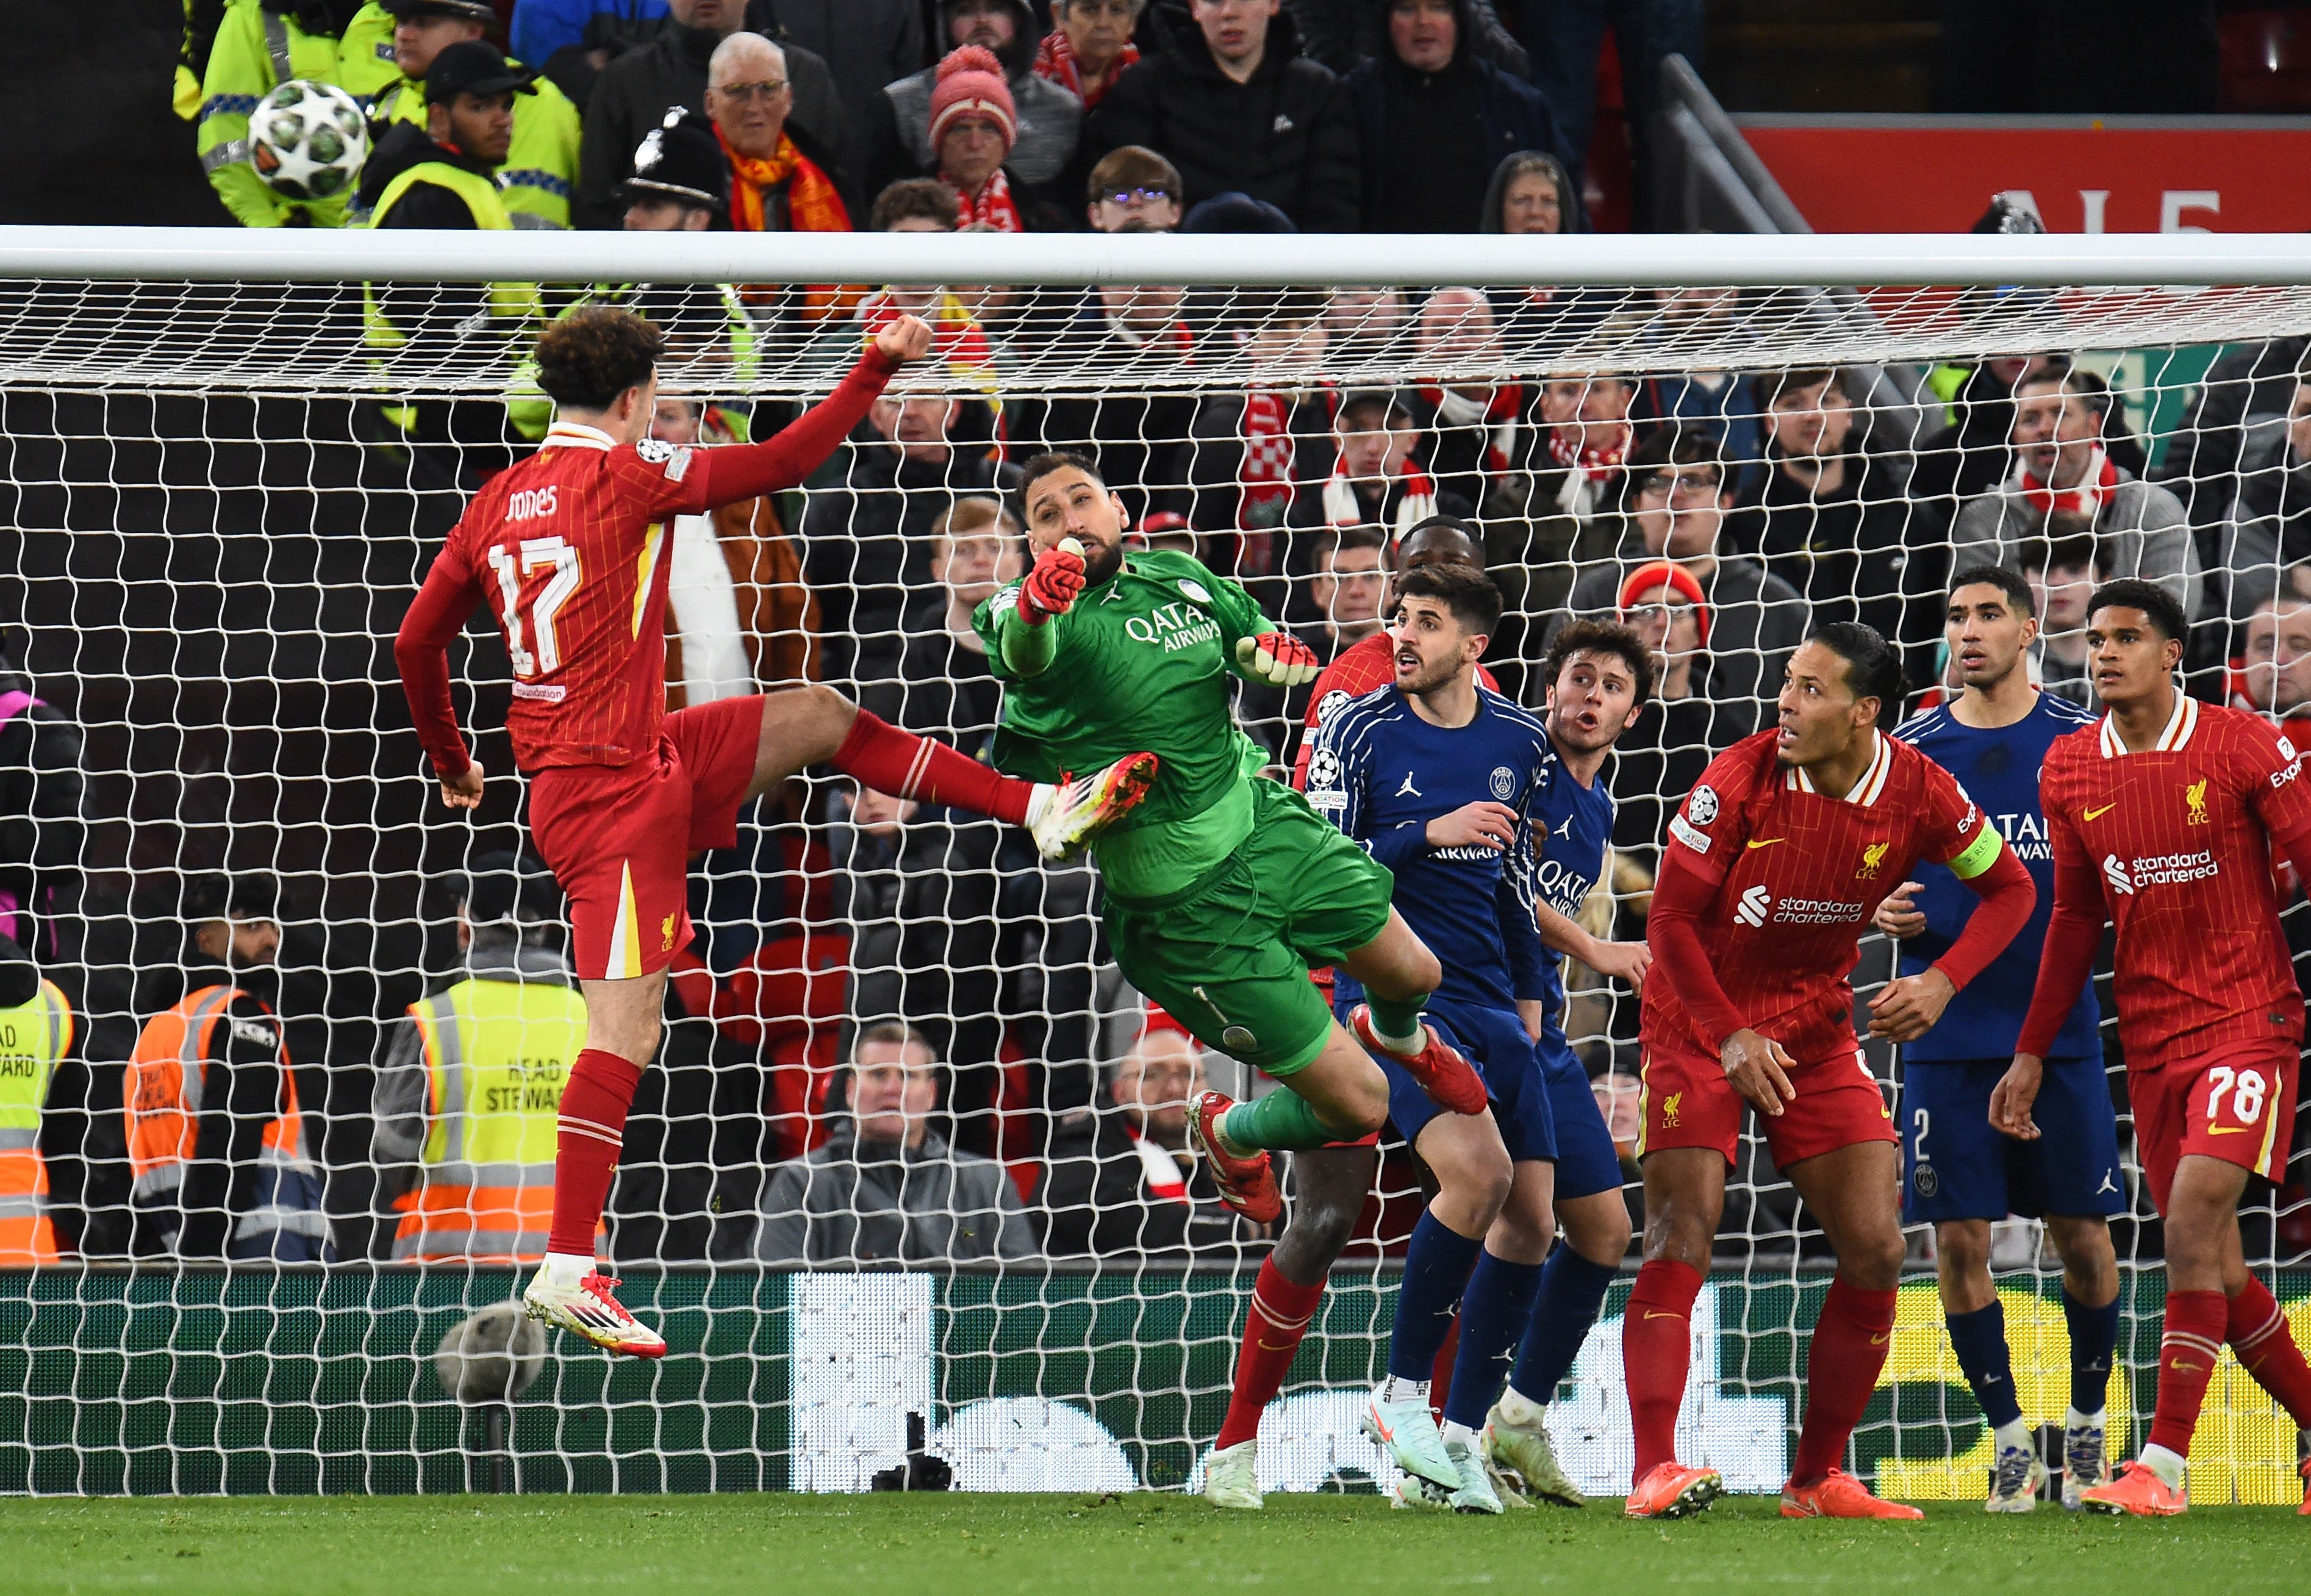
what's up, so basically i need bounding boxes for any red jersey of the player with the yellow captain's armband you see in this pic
[1641,730,1999,1065]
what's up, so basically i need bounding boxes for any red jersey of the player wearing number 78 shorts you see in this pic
[2020,693,2311,1070]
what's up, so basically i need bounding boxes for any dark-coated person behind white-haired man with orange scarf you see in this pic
[571,0,850,231]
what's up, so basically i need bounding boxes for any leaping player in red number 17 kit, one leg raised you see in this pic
[393,307,1153,1358]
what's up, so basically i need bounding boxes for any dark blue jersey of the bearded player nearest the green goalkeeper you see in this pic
[1308,686,1555,1009]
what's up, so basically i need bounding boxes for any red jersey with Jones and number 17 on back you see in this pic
[428,423,705,771]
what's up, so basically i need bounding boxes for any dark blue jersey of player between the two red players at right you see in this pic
[1895,693,2101,1065]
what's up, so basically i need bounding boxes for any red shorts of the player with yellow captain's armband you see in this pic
[1636,1047,1900,1168]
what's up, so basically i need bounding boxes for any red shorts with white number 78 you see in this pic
[2126,1039,2302,1212]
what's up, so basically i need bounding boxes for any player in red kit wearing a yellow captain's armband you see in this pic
[1620,621,2043,1517]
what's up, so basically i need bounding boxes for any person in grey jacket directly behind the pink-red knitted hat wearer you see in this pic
[867,0,1084,206]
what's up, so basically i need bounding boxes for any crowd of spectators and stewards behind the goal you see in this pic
[0,0,2311,1265]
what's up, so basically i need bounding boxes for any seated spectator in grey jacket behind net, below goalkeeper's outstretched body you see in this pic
[753,1021,1035,1268]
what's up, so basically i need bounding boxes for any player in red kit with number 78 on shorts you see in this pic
[1990,580,2311,1517]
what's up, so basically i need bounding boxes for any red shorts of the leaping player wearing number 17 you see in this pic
[529,698,762,982]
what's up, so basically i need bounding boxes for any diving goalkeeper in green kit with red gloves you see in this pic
[973,455,1486,1222]
